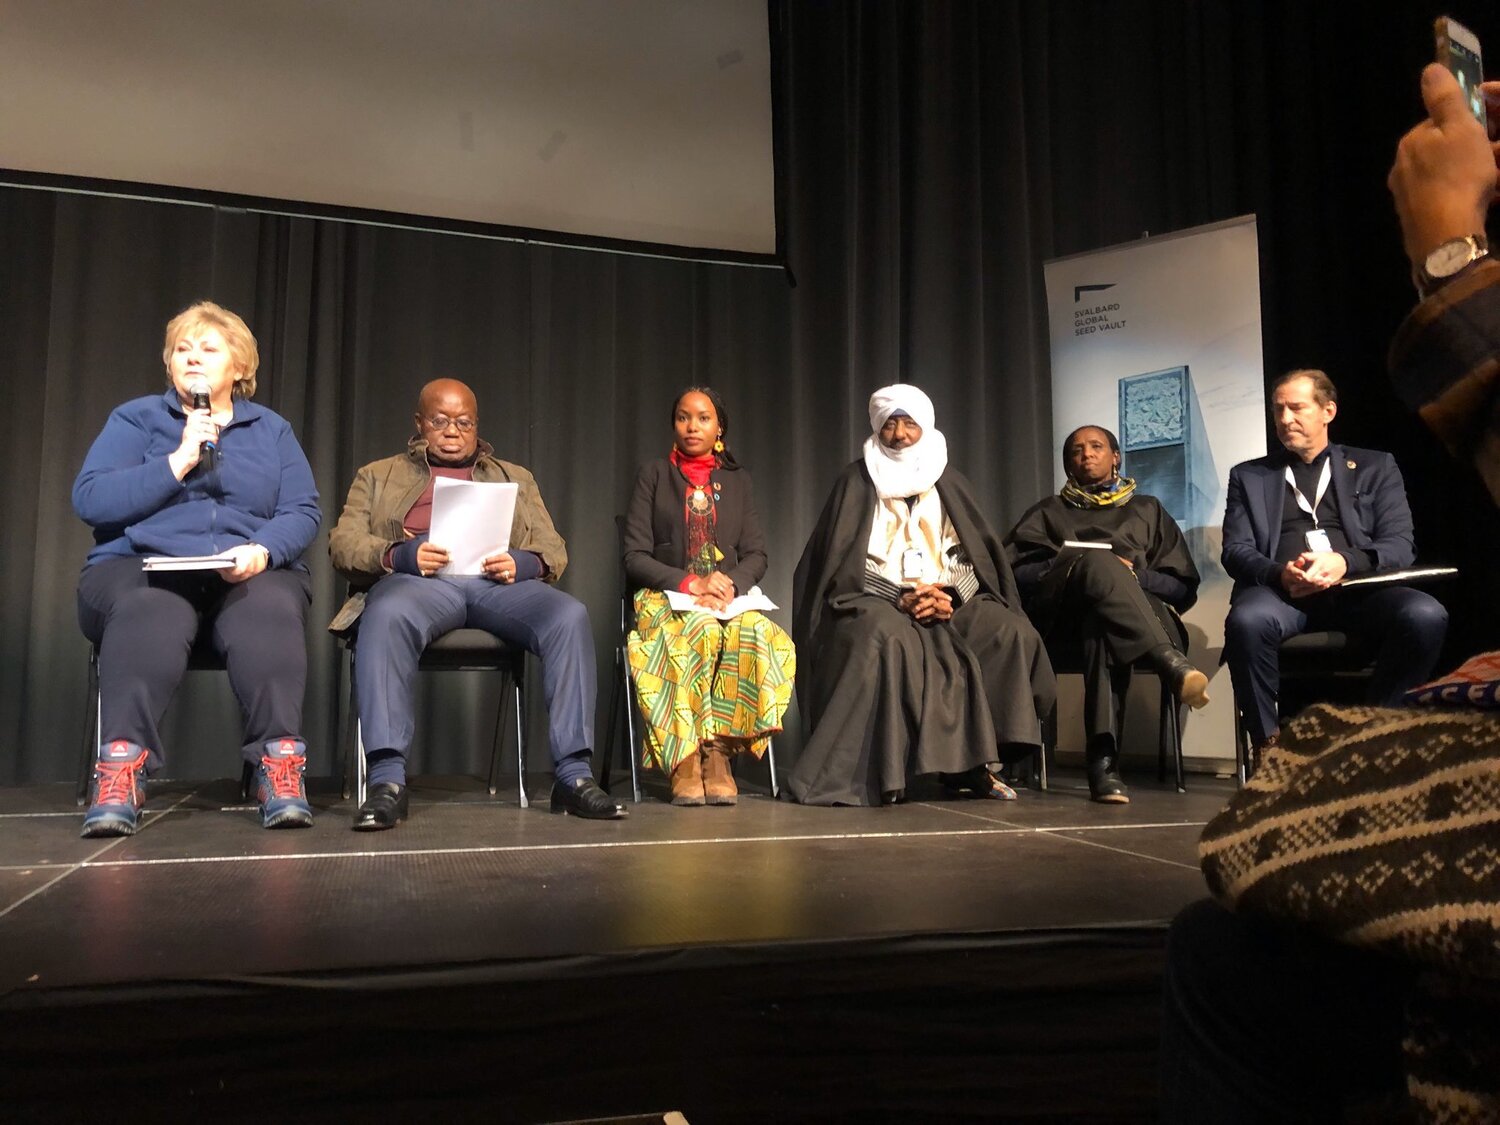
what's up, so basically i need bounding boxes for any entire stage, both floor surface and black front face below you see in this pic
[0,773,1232,1125]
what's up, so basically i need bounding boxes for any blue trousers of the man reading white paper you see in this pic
[354,575,597,762]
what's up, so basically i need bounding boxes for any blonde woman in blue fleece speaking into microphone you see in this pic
[74,302,321,837]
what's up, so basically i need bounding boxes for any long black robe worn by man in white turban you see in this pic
[788,461,1056,806]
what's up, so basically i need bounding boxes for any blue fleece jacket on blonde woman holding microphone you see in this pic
[74,390,323,567]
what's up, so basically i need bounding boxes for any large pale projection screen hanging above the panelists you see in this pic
[0,0,779,264]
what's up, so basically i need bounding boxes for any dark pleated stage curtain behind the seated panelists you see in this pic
[0,0,1500,783]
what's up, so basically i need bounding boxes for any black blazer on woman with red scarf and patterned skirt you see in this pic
[623,458,767,594]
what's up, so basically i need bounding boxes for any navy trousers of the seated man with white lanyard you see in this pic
[1224,587,1448,744]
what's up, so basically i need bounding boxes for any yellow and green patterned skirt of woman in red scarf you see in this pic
[626,590,797,774]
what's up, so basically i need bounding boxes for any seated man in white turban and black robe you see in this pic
[788,383,1056,806]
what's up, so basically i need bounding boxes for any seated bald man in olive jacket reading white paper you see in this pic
[329,380,626,831]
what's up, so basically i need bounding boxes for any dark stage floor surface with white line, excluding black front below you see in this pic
[0,773,1232,999]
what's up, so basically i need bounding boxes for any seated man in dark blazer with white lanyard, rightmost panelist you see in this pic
[1221,371,1448,759]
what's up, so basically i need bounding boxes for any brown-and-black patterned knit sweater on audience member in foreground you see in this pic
[1199,704,1500,1122]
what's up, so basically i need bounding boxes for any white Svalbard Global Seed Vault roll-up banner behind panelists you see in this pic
[1044,216,1266,761]
